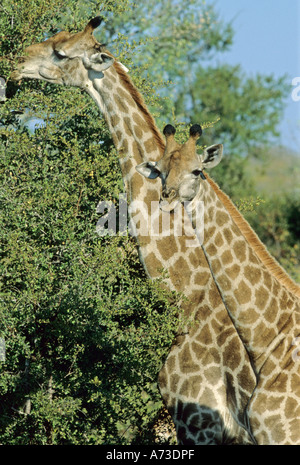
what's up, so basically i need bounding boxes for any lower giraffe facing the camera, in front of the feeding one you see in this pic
[137,125,300,445]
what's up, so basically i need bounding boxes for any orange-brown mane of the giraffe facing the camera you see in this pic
[207,176,300,297]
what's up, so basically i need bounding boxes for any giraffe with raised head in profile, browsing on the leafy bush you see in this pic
[11,17,256,444]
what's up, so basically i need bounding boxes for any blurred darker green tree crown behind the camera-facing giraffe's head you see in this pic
[176,65,288,155]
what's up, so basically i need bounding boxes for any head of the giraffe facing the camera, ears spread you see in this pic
[136,124,223,211]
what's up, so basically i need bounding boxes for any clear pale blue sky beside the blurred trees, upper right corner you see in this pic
[213,0,300,154]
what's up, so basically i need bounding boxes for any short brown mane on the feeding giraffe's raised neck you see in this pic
[113,61,165,155]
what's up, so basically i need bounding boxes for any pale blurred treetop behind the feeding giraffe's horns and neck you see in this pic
[105,0,233,124]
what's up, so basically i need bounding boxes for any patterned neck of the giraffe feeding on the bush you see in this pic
[86,63,192,280]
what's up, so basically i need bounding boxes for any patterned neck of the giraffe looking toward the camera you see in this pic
[193,177,300,373]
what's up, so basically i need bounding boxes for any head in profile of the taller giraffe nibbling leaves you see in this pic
[11,17,114,88]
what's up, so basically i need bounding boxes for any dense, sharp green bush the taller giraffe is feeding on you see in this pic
[0,0,182,444]
